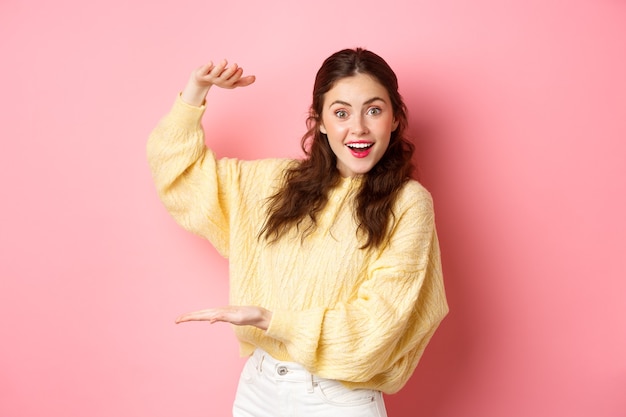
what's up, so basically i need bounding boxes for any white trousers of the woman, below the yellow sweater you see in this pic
[233,349,387,417]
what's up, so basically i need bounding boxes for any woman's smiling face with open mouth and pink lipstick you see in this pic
[320,74,398,177]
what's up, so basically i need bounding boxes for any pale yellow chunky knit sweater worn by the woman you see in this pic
[148,97,448,393]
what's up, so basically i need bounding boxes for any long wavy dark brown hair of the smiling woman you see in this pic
[260,48,415,249]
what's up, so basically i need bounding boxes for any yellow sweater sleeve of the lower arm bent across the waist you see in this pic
[267,190,448,392]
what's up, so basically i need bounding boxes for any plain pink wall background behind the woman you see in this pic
[0,0,626,417]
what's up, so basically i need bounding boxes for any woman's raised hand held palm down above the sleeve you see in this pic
[181,59,256,106]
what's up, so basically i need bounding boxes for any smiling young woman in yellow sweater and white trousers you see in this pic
[148,48,448,417]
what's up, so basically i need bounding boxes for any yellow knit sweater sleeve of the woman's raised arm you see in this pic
[147,96,238,257]
